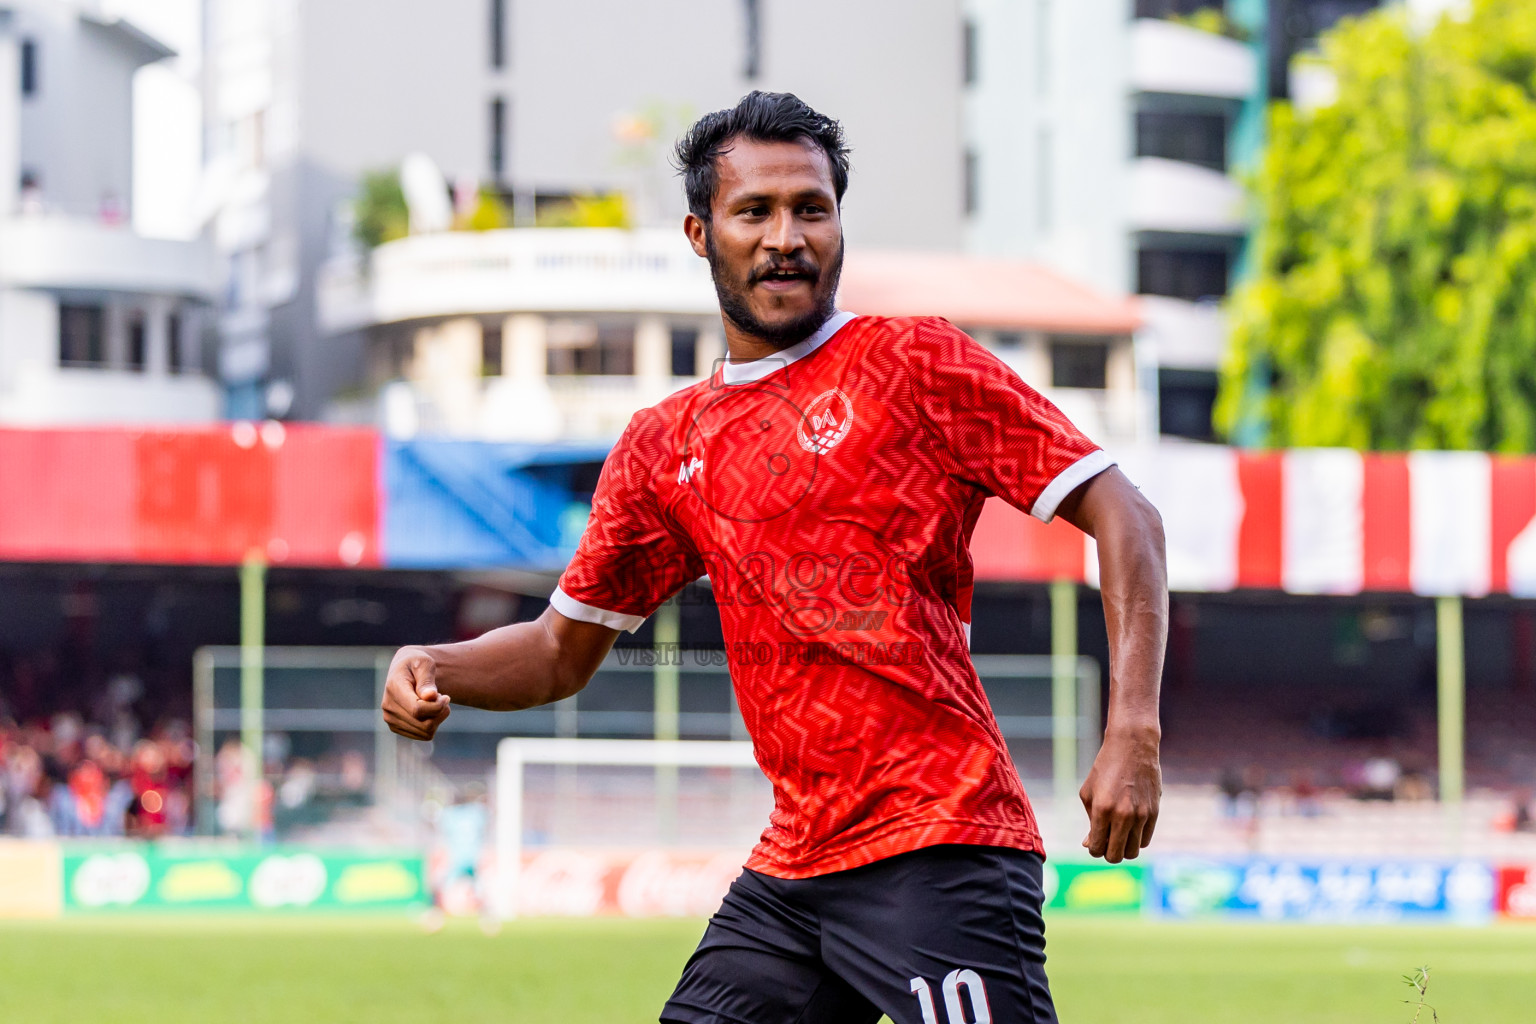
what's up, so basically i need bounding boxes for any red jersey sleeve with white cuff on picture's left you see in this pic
[550,413,703,633]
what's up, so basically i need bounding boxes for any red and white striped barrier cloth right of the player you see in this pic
[971,445,1536,597]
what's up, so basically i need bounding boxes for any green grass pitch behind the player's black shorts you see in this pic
[0,917,1536,1024]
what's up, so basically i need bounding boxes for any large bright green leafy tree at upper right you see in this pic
[1217,0,1536,451]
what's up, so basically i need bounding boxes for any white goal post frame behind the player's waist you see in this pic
[495,737,762,918]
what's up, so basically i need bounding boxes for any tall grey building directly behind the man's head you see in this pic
[204,0,965,418]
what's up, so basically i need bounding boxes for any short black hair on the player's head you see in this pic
[673,89,848,224]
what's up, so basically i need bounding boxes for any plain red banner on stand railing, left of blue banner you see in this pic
[0,422,381,567]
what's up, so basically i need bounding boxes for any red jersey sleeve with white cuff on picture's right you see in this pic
[908,319,1115,522]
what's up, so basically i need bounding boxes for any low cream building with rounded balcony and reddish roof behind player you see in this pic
[319,229,1154,445]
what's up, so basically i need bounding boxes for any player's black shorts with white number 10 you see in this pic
[662,846,1057,1024]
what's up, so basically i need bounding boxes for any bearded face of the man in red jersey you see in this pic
[684,138,843,348]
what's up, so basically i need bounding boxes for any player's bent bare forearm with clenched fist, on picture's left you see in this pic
[382,608,619,740]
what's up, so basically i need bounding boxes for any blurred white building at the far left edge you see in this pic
[0,0,220,424]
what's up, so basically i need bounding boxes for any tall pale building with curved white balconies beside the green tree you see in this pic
[963,0,1379,439]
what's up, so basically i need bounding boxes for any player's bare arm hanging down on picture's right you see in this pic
[1057,468,1167,864]
